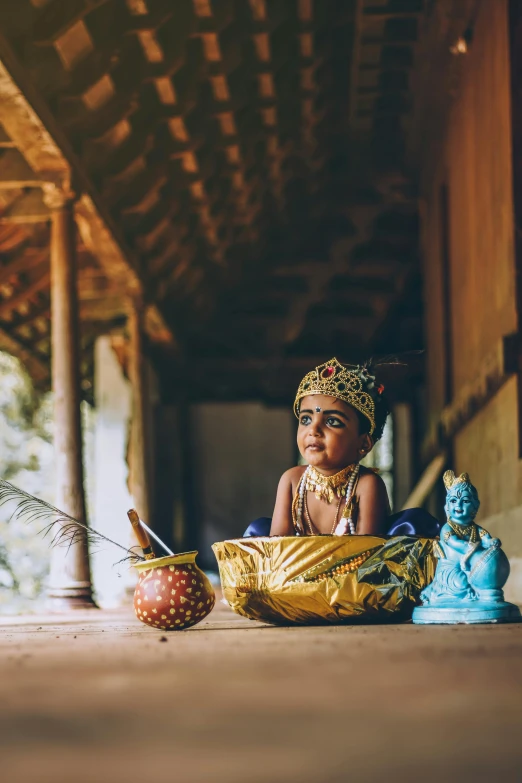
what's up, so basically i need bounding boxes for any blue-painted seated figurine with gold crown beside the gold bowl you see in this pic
[413,470,520,624]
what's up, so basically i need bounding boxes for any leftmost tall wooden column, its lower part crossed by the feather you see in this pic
[45,188,95,610]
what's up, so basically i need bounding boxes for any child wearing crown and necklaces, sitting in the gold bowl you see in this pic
[245,359,438,536]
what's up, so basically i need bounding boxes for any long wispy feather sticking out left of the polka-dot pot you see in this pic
[0,479,145,565]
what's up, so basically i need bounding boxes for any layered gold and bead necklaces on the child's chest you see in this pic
[292,464,360,536]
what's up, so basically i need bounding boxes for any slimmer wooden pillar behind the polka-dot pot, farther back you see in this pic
[127,298,152,524]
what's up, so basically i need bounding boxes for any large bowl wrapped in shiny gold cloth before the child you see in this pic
[212,536,436,625]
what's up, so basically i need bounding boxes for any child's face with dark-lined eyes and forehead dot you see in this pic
[297,394,373,473]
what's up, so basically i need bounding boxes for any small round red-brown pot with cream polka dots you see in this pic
[134,552,216,631]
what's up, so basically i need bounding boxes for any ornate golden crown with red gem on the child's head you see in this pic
[294,359,375,435]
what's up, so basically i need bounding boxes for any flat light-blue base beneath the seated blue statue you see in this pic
[412,601,522,625]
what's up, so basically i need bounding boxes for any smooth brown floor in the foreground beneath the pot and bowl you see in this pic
[0,604,522,783]
